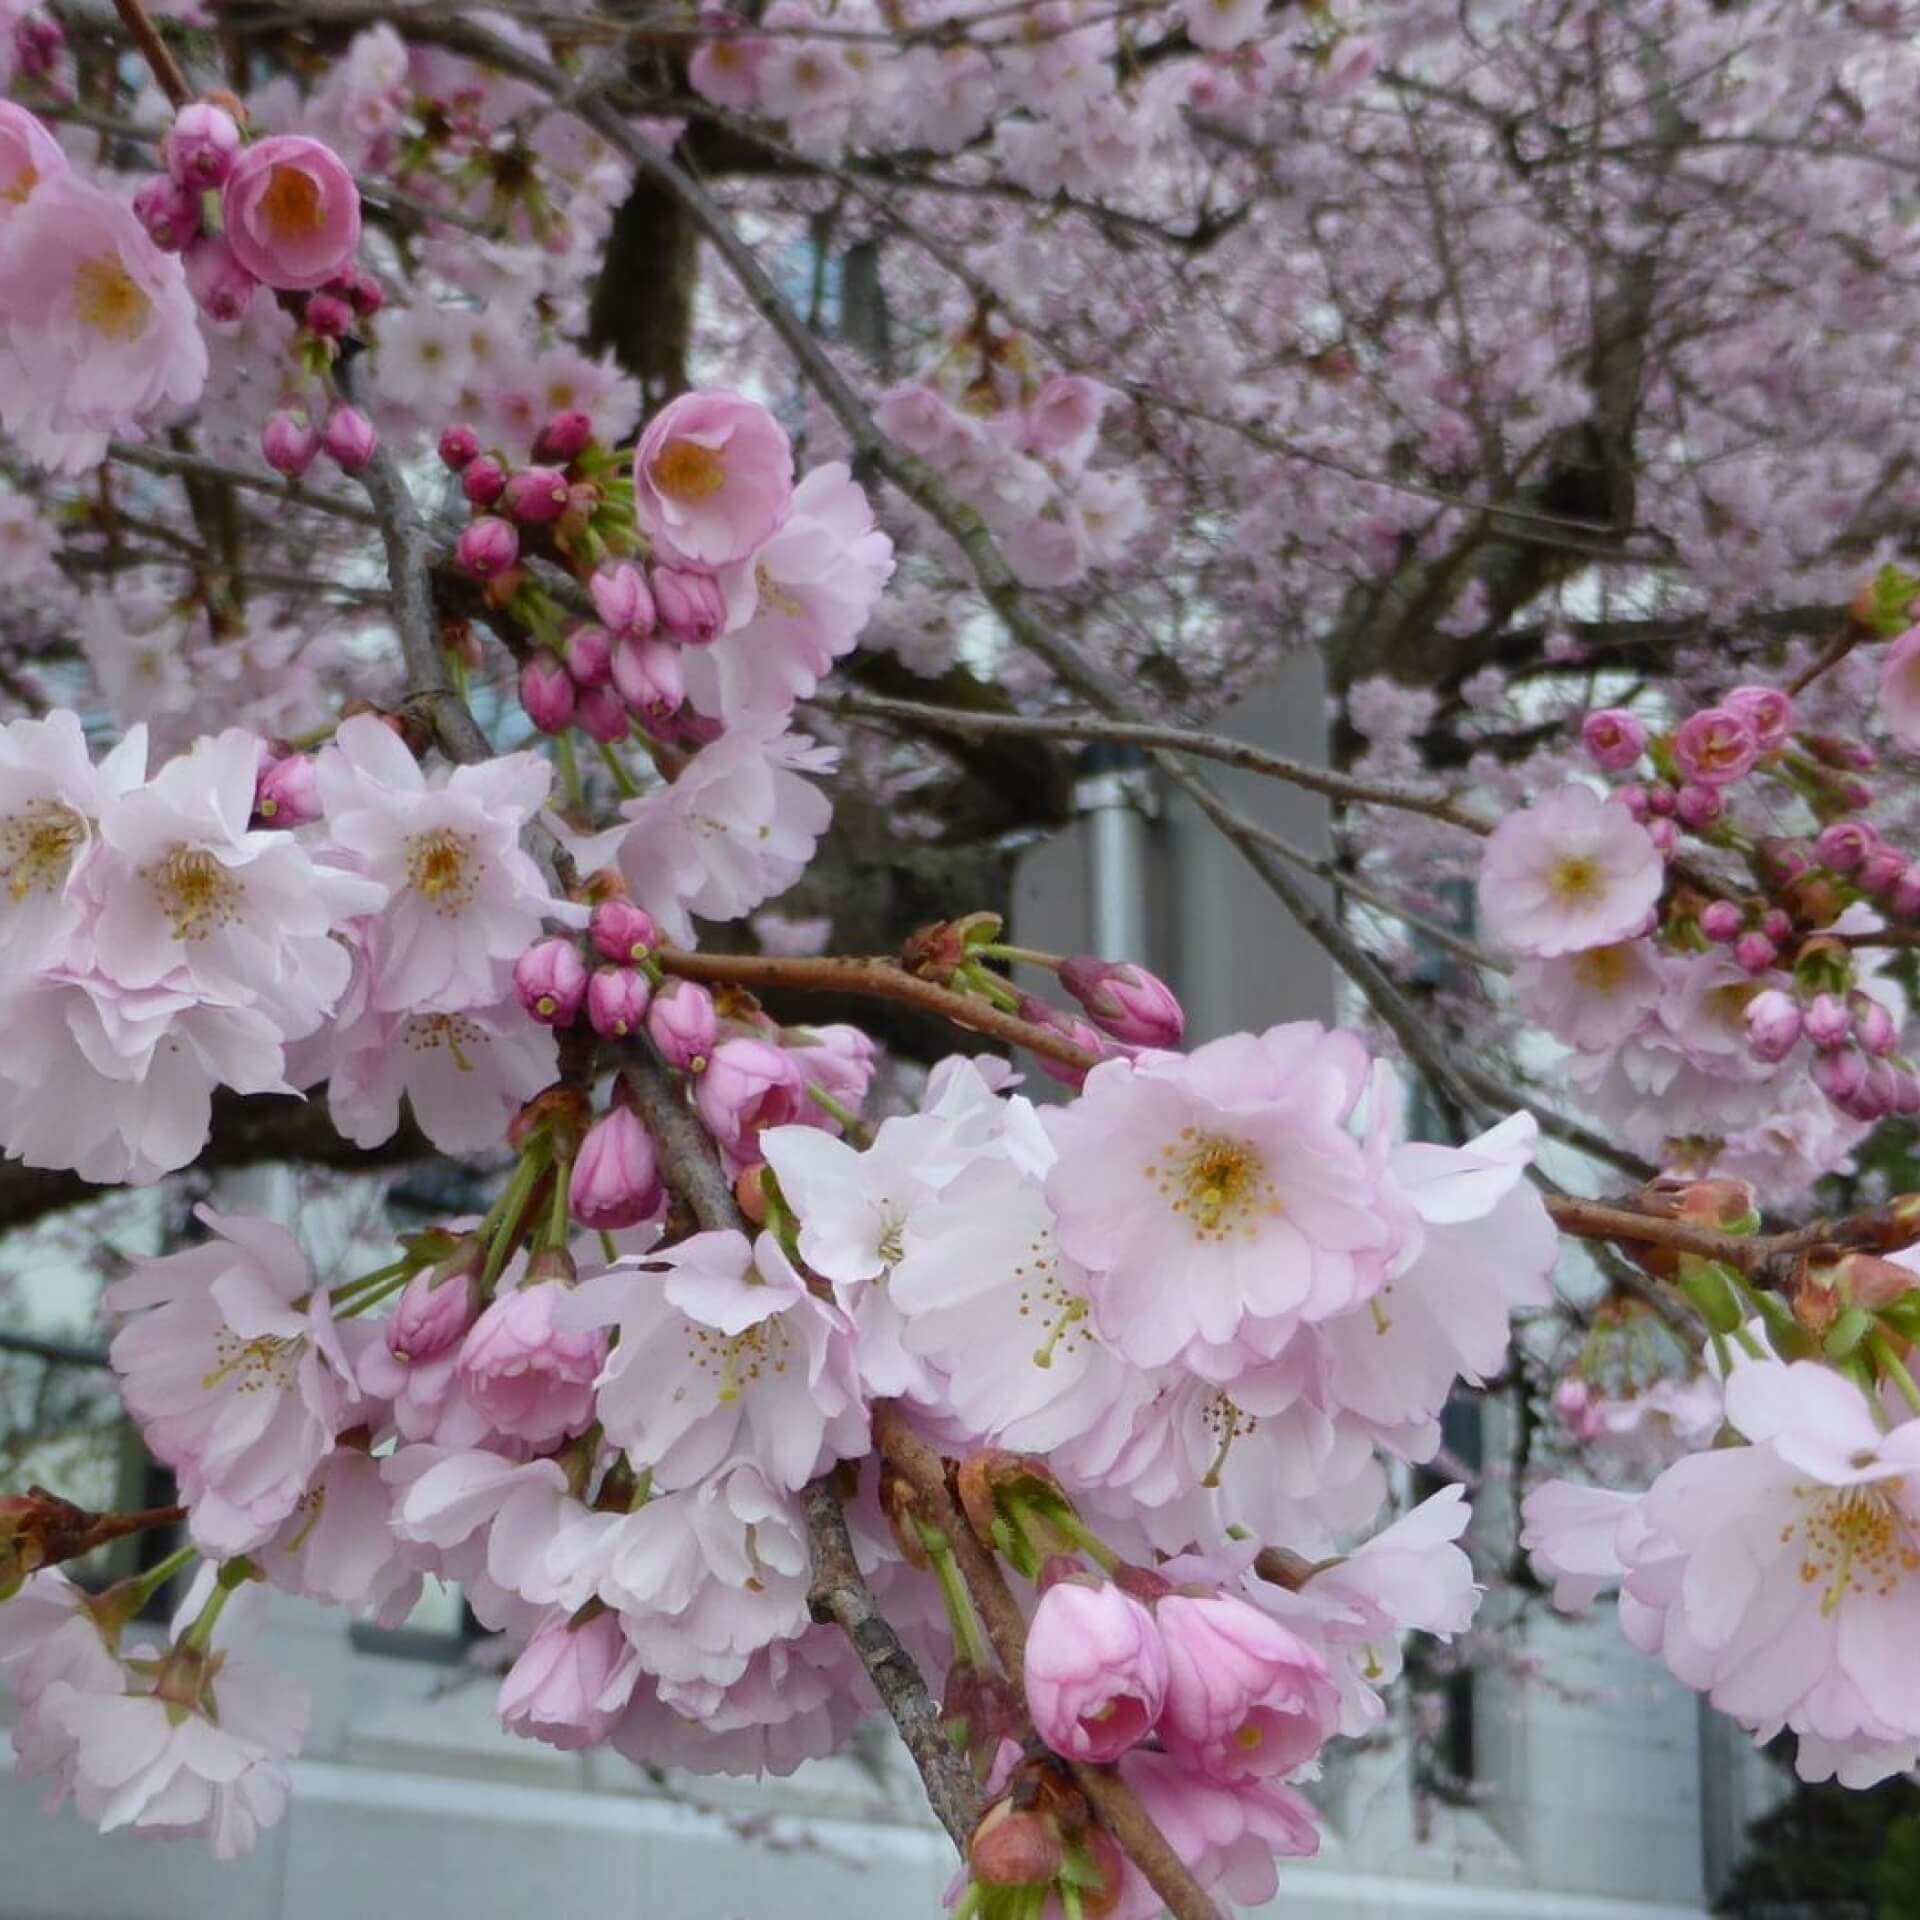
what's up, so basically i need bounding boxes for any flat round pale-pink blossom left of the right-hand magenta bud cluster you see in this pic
[1480,785,1665,958]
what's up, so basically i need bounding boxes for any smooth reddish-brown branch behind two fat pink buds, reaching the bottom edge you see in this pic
[874,1400,1221,1920]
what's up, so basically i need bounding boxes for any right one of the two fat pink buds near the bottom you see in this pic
[1154,1594,1340,1782]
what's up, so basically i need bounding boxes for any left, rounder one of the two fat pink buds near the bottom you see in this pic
[1025,1580,1167,1763]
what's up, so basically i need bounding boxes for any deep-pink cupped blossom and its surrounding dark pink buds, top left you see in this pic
[132,107,364,326]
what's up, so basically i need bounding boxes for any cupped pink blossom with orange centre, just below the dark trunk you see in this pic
[634,392,793,566]
